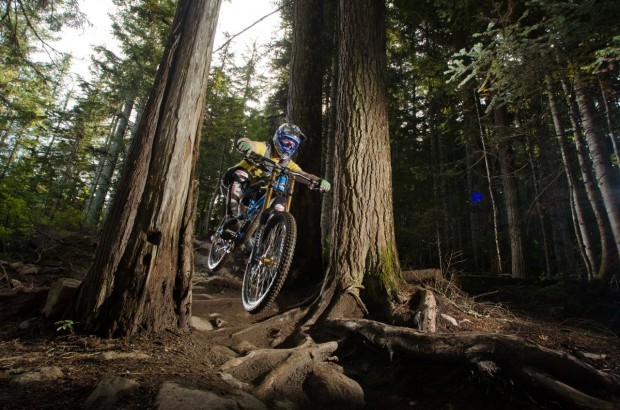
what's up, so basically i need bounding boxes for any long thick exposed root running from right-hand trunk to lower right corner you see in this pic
[326,319,620,409]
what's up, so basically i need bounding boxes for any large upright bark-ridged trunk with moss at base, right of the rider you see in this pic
[329,0,400,316]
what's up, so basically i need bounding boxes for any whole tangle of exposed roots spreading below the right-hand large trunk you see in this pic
[208,270,620,409]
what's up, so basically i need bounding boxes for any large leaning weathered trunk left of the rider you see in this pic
[74,0,221,336]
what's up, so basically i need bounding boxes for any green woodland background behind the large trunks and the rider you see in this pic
[0,0,620,287]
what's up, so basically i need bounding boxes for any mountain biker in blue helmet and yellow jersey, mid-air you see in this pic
[222,123,331,233]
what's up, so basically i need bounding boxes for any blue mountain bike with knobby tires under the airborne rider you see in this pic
[207,152,319,313]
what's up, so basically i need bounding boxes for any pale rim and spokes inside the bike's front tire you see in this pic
[243,223,286,310]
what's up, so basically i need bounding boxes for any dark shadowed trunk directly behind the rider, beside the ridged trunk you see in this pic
[287,0,323,277]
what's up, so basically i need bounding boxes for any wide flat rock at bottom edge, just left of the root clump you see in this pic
[154,382,267,410]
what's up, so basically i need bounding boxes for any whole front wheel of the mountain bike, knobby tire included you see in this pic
[241,212,297,313]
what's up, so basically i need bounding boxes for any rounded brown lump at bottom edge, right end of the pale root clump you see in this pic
[303,365,365,409]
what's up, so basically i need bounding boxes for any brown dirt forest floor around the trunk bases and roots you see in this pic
[0,232,620,410]
